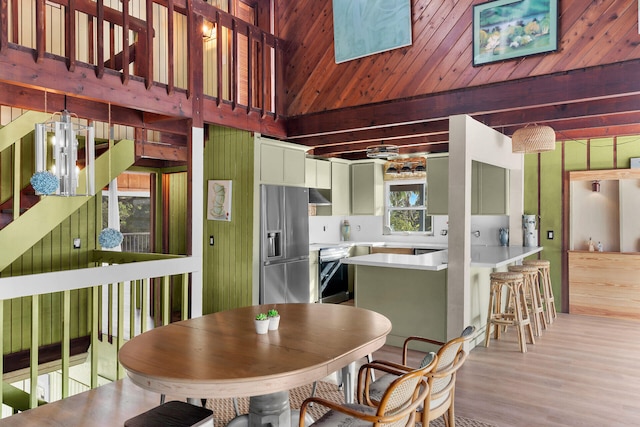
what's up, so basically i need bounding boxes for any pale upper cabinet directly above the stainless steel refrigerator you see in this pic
[256,136,308,187]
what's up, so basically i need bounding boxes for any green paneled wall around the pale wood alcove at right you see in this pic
[524,136,640,309]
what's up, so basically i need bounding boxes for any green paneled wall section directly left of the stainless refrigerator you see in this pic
[202,126,254,314]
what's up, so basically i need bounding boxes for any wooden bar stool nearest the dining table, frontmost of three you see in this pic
[484,272,536,353]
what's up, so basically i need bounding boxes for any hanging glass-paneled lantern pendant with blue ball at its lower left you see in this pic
[31,110,95,196]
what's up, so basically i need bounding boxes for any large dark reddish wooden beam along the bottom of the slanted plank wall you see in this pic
[287,59,640,146]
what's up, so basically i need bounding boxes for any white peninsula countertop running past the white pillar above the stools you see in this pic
[341,245,542,271]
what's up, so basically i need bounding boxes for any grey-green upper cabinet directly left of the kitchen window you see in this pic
[351,162,384,219]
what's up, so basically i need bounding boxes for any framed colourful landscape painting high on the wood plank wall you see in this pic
[473,0,558,66]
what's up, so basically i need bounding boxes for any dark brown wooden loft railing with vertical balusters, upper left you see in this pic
[0,0,283,117]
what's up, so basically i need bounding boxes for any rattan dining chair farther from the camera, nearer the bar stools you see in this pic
[358,326,476,427]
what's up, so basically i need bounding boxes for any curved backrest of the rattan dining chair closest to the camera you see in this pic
[374,352,438,427]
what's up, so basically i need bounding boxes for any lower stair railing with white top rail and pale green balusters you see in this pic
[0,251,201,414]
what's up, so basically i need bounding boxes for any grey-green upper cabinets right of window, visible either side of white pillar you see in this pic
[427,156,509,215]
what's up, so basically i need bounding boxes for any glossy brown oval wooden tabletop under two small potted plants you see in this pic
[118,304,391,412]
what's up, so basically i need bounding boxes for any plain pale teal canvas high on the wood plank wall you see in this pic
[333,0,412,64]
